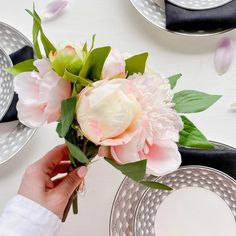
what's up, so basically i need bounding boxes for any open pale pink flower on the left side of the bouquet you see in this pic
[14,59,71,128]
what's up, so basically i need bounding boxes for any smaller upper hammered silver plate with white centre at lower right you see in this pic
[134,166,236,236]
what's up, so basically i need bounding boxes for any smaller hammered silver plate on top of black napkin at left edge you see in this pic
[0,48,14,120]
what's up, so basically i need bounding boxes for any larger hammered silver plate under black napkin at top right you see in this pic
[130,0,233,36]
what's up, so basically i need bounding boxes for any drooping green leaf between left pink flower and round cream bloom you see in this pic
[57,97,77,138]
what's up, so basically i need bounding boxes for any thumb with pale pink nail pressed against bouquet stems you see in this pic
[57,166,88,198]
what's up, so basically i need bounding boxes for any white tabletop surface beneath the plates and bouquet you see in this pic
[0,0,236,236]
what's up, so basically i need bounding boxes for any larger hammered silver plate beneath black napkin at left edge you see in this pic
[0,22,35,164]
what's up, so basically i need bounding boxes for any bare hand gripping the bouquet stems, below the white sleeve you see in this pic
[18,145,87,219]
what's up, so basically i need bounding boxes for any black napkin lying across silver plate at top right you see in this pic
[165,0,236,31]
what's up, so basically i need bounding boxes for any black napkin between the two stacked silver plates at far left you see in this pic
[0,46,34,123]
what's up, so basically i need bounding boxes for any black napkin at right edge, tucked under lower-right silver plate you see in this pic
[179,147,236,179]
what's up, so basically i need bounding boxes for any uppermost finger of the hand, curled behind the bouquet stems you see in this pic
[36,144,69,175]
